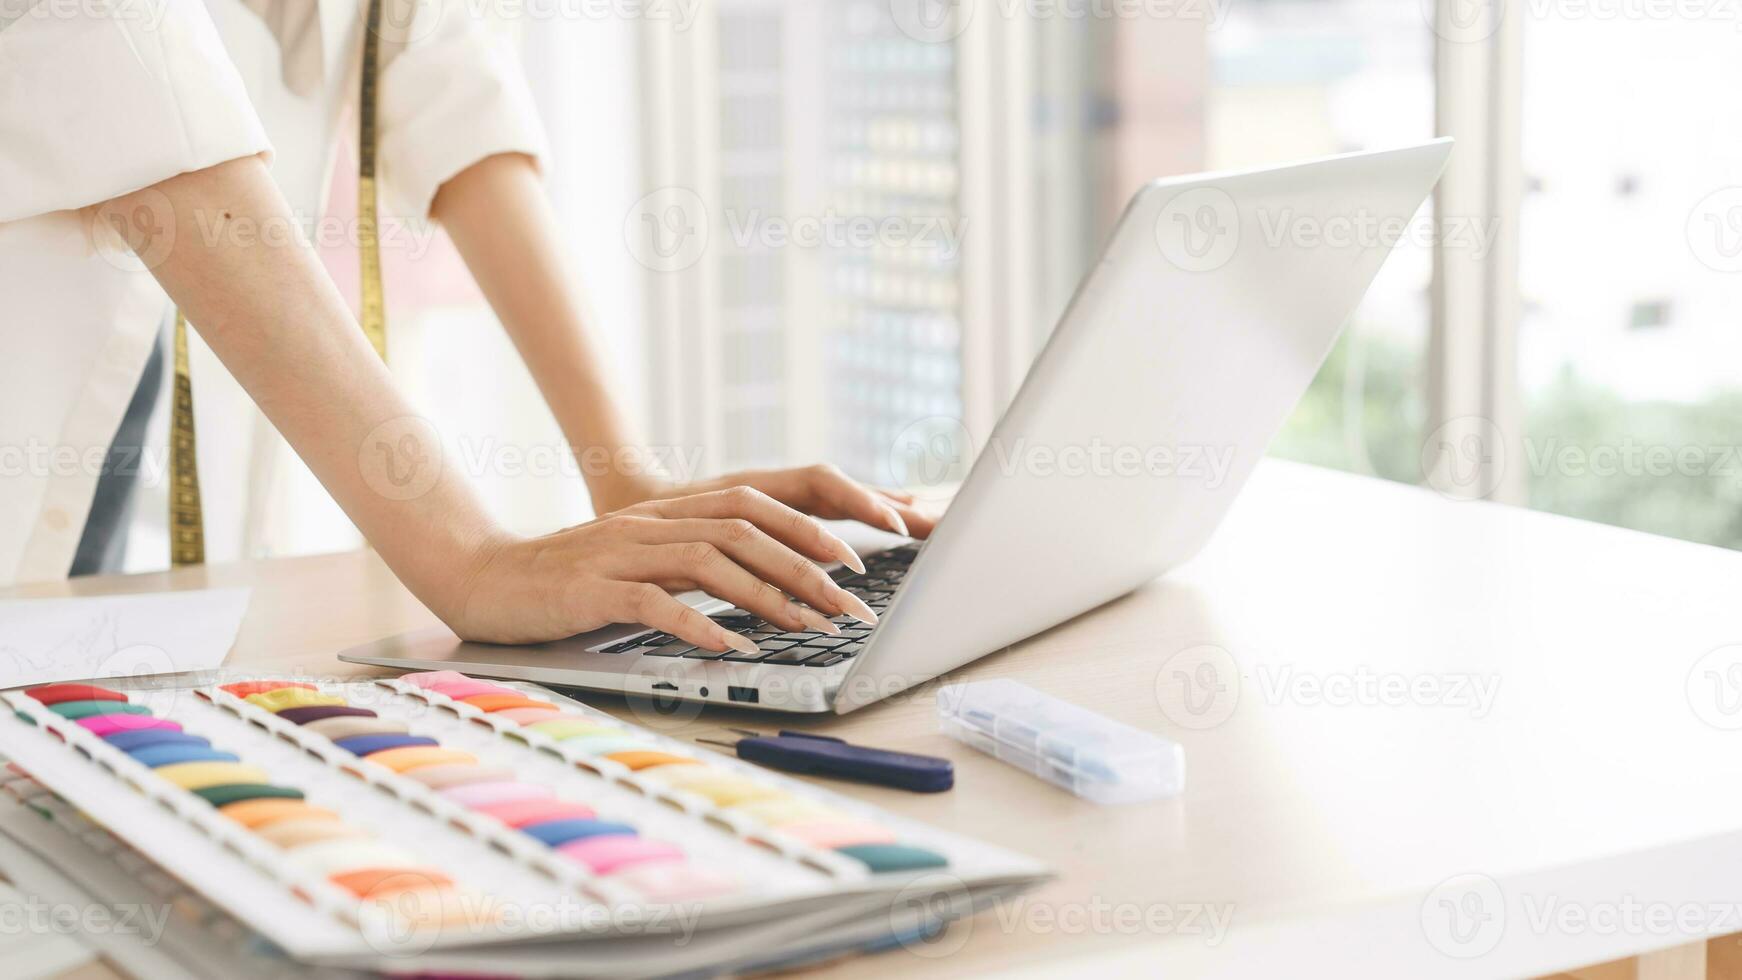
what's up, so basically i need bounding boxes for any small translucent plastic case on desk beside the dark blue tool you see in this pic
[937,679,1186,802]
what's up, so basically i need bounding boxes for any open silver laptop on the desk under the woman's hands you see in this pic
[340,139,1451,712]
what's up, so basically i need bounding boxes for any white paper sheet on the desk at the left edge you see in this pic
[0,588,249,688]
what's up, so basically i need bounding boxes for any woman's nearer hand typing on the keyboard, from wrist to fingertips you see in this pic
[437,486,876,653]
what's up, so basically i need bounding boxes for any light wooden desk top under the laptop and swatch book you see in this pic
[9,463,1742,977]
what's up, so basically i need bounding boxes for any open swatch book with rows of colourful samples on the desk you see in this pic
[0,670,1047,977]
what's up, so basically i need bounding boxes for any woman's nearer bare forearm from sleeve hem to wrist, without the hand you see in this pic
[98,158,503,618]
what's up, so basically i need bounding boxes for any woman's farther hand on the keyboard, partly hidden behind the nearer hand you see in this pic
[599,463,937,539]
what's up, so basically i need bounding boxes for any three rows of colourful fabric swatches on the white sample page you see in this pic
[13,670,948,909]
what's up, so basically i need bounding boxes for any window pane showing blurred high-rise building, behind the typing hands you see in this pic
[702,0,963,482]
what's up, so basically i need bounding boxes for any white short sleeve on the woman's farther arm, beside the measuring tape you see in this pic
[378,2,545,218]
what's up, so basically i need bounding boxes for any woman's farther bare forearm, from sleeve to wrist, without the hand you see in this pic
[432,153,648,512]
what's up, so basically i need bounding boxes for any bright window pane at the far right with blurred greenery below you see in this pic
[1519,14,1742,547]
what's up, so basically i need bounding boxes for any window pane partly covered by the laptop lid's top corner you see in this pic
[1205,0,1435,482]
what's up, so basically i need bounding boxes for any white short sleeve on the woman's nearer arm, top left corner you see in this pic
[0,0,272,221]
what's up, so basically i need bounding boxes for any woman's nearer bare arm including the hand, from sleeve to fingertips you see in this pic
[94,158,898,654]
